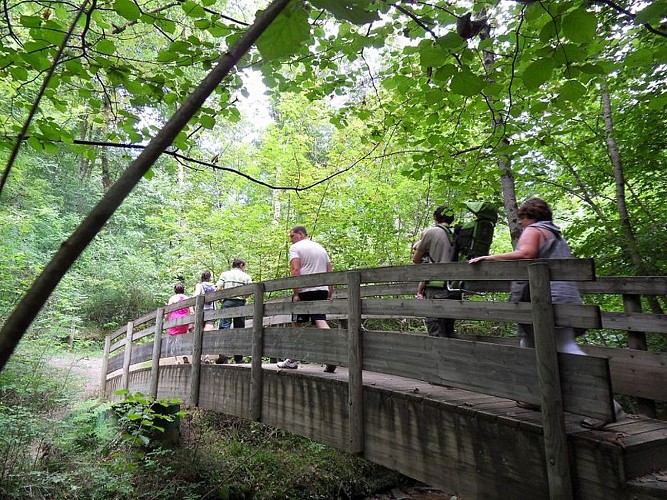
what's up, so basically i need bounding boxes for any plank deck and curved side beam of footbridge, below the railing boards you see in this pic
[109,364,667,499]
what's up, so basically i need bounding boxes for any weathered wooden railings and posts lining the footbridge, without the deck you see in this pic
[101,259,667,498]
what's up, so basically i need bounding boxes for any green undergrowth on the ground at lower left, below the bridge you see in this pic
[0,351,405,500]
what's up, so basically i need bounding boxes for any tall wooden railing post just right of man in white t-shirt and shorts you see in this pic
[347,271,364,453]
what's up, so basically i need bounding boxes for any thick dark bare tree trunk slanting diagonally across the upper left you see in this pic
[0,0,290,370]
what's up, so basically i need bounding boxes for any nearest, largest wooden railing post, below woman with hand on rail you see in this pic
[528,262,572,500]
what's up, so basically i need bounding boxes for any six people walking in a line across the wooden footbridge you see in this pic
[165,198,604,378]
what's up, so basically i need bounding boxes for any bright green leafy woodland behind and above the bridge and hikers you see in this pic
[0,0,667,364]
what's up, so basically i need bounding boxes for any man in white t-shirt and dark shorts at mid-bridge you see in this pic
[278,226,336,373]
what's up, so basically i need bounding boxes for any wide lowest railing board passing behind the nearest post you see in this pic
[363,332,613,421]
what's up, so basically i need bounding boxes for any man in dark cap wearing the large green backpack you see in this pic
[412,205,461,338]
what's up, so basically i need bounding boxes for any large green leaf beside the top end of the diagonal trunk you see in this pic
[257,9,310,61]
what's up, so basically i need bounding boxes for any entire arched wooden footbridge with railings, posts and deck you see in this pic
[101,259,667,499]
